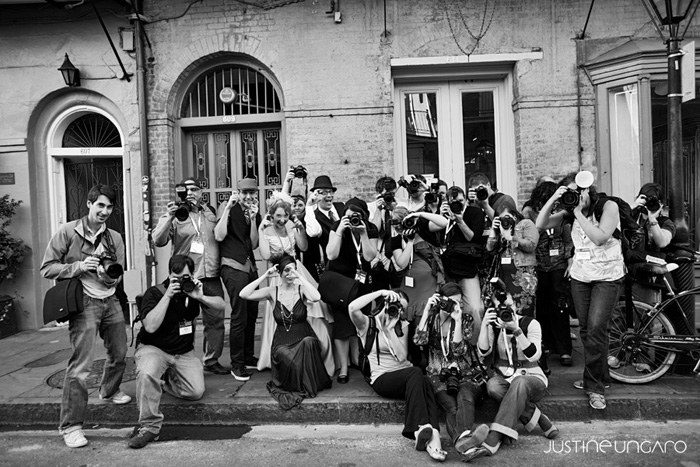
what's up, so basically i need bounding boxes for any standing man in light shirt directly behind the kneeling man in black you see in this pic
[153,177,228,375]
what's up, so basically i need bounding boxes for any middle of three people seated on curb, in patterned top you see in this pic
[413,282,489,454]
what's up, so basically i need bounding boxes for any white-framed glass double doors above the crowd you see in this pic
[396,80,516,193]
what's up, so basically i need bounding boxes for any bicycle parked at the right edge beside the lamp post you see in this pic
[608,258,700,384]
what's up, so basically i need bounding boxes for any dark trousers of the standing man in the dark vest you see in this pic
[221,266,258,369]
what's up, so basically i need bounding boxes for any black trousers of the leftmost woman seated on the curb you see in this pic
[372,367,440,439]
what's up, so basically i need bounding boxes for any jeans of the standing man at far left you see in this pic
[58,294,128,430]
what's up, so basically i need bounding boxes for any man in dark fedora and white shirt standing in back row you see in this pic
[304,175,344,281]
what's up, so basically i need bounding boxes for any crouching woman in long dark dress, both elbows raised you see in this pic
[240,255,331,409]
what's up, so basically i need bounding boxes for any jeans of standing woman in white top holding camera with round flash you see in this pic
[571,279,623,394]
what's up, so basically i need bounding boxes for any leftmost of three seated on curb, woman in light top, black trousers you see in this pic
[348,290,446,461]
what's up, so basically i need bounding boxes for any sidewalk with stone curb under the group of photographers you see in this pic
[0,326,700,427]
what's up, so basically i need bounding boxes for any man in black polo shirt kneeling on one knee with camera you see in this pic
[128,255,225,449]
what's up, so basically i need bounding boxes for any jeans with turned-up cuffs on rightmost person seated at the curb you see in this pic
[486,374,547,439]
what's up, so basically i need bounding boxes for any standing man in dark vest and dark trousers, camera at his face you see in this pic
[214,178,262,381]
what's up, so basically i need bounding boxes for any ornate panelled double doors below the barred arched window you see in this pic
[183,128,284,208]
